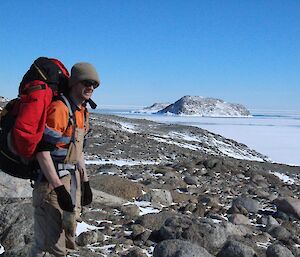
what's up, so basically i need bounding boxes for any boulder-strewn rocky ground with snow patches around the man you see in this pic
[0,112,300,257]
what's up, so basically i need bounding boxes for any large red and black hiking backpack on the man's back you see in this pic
[0,57,70,179]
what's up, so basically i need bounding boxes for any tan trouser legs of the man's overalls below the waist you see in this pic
[29,171,81,257]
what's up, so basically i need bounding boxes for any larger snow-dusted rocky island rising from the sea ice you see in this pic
[157,96,250,117]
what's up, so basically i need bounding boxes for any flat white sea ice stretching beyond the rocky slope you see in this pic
[109,111,300,165]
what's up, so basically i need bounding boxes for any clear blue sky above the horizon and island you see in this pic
[0,0,300,110]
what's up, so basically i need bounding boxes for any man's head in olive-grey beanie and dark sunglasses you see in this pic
[69,62,100,102]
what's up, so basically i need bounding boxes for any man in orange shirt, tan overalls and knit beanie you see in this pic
[29,63,100,257]
